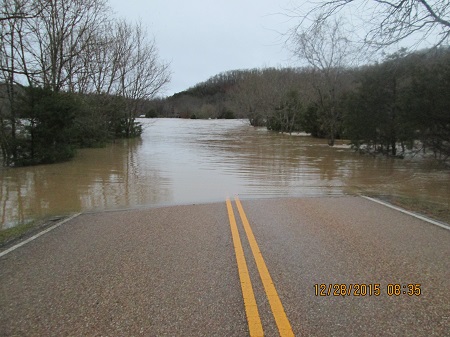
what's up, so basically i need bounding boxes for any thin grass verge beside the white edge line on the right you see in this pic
[370,194,450,224]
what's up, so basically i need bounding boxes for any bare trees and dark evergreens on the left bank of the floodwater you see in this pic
[0,0,170,166]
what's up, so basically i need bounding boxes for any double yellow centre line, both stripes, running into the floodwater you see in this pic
[226,197,294,337]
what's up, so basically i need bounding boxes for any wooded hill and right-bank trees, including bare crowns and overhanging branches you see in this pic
[152,0,450,162]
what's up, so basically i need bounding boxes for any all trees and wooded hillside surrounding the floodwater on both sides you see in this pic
[0,0,450,167]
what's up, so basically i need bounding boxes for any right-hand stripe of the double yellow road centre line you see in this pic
[235,197,294,337]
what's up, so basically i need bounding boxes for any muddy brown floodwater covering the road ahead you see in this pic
[0,119,450,228]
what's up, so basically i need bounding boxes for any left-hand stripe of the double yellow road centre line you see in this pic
[226,199,264,337]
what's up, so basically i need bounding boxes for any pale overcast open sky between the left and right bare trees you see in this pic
[110,0,295,95]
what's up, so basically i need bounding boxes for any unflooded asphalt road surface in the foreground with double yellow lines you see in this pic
[0,197,450,336]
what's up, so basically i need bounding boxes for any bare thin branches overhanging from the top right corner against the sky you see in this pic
[292,0,450,48]
